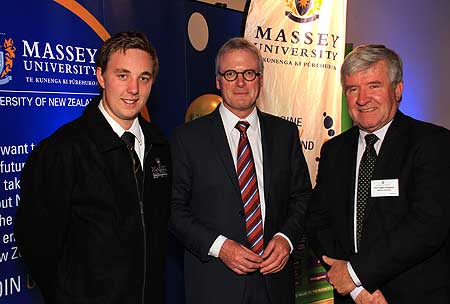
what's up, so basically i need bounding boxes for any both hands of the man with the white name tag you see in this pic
[322,255,387,304]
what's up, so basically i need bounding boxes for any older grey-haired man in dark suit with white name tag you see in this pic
[310,45,450,304]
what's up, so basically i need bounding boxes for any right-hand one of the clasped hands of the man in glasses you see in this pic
[260,235,291,275]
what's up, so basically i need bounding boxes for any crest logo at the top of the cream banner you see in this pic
[285,0,323,23]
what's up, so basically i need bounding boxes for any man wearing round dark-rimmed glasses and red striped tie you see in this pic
[170,38,311,304]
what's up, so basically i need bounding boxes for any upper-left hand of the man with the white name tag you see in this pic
[322,255,356,296]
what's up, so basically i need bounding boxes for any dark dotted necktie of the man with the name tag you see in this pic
[356,134,378,249]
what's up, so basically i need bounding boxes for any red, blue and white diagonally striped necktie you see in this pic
[236,121,264,255]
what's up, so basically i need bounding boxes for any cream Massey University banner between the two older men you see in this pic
[245,0,347,184]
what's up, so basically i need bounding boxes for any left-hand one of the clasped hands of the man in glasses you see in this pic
[219,239,263,274]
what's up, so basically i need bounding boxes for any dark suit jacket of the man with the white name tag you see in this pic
[309,112,450,303]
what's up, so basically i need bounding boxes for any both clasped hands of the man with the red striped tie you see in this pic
[219,235,291,275]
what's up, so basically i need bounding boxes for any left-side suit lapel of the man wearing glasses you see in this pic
[209,107,241,199]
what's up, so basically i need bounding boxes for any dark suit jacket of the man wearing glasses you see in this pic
[170,108,311,304]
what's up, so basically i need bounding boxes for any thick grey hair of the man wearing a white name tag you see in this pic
[341,44,403,87]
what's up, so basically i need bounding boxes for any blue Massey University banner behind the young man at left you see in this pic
[0,0,107,304]
